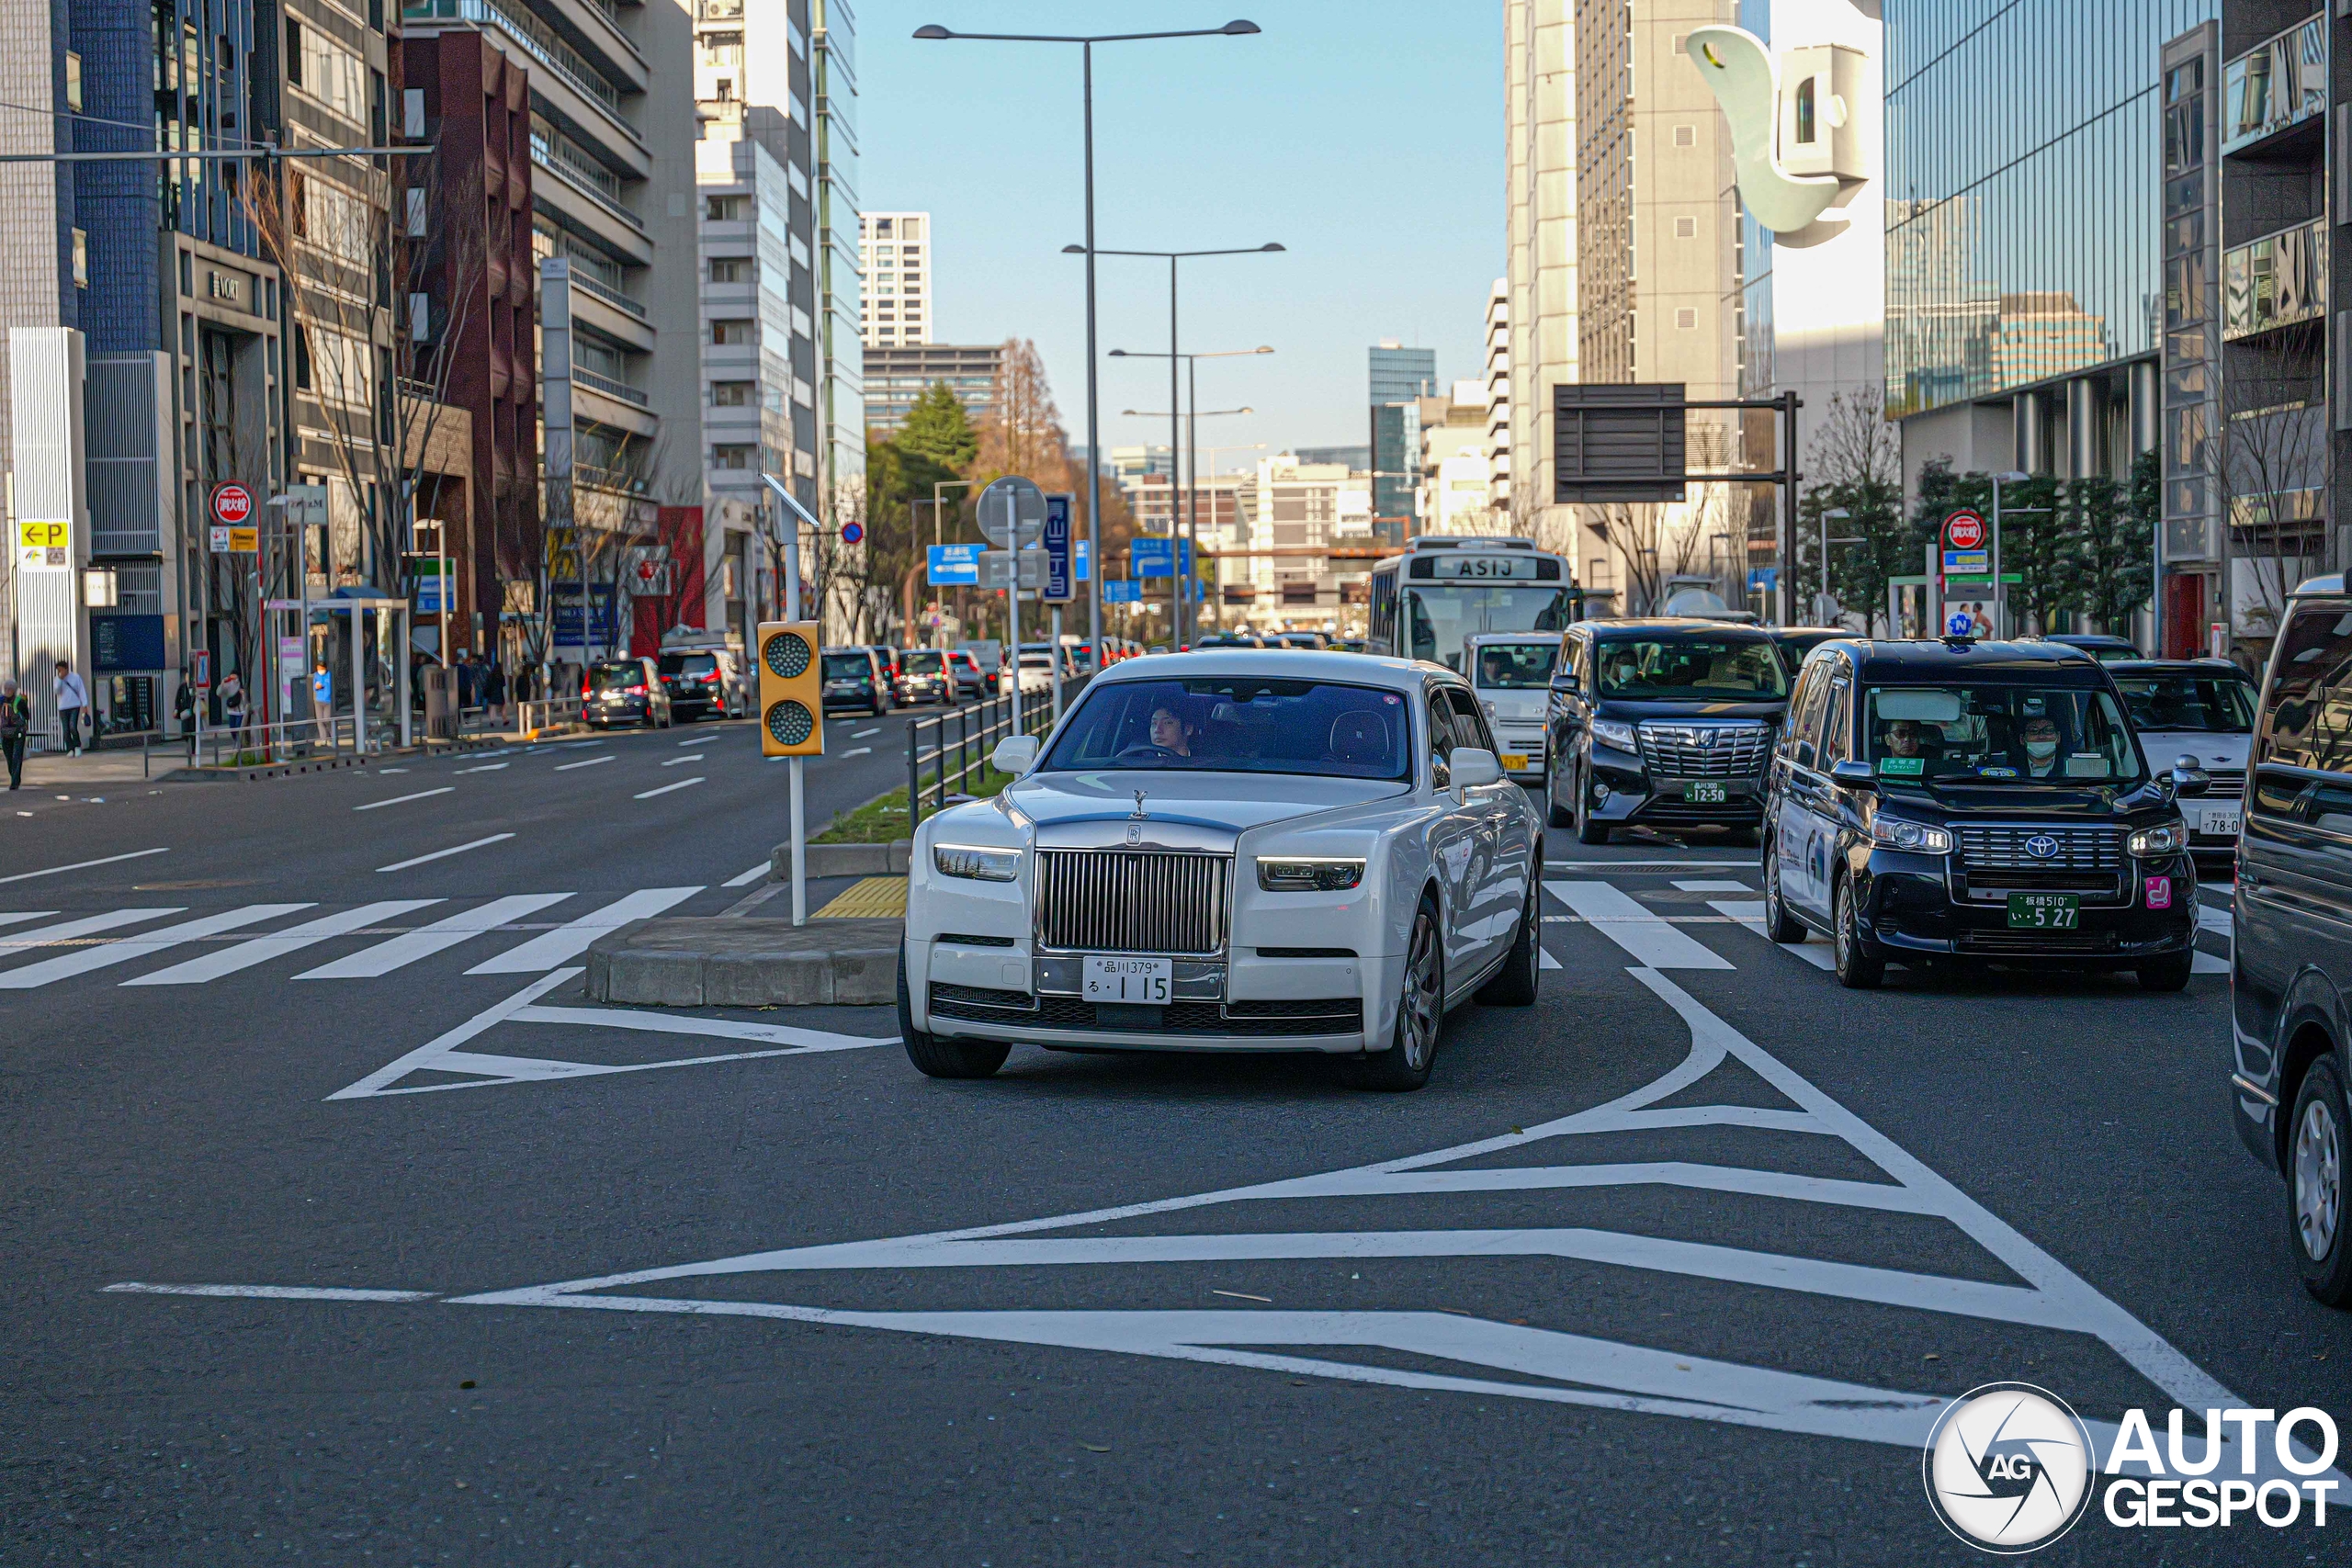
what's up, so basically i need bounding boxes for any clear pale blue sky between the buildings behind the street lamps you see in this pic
[858,0,1505,468]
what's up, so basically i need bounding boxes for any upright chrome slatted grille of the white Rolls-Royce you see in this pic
[1037,849,1232,954]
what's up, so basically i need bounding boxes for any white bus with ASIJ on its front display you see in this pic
[1364,536,1585,670]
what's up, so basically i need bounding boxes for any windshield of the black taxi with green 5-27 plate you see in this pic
[1863,686,2143,785]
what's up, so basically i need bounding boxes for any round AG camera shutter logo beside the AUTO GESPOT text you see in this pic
[1922,1382,2098,1556]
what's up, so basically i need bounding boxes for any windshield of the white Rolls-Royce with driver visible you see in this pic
[1045,674,1411,778]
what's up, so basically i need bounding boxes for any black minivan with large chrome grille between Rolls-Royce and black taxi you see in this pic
[1543,618,1788,844]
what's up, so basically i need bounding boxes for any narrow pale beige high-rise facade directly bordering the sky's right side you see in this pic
[1488,0,1580,555]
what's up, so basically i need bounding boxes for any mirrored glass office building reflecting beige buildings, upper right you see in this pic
[1884,0,2218,423]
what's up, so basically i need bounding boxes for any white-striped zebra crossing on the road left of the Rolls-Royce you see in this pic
[0,884,703,989]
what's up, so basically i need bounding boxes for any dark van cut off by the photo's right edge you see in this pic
[2230,573,2352,1307]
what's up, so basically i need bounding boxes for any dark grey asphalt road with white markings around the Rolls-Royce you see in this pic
[0,757,2352,1568]
